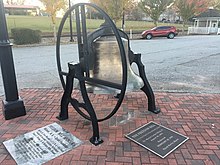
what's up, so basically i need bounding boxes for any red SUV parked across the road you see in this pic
[141,26,178,40]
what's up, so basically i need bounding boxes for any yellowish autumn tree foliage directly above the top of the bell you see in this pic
[90,0,135,23]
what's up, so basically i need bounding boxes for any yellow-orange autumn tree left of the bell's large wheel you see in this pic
[40,0,66,41]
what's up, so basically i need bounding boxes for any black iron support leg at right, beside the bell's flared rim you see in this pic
[134,54,160,114]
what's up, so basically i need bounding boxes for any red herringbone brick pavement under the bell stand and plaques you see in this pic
[0,89,220,165]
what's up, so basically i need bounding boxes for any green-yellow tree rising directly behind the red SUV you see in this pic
[140,0,173,26]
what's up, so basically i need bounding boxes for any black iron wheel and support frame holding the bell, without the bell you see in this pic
[56,3,160,145]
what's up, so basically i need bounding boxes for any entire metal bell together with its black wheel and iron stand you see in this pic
[56,3,160,145]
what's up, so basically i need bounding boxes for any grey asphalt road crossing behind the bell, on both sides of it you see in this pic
[0,35,220,95]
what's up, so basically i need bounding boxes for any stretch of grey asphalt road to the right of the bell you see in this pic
[132,36,220,93]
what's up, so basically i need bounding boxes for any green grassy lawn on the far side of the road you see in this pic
[6,16,186,34]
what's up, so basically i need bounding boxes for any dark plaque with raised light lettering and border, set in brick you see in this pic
[125,122,189,158]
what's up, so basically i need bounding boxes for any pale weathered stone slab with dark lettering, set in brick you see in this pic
[3,123,82,165]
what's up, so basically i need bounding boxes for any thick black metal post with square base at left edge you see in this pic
[0,0,26,120]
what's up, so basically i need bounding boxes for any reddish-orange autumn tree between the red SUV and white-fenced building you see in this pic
[174,0,210,31]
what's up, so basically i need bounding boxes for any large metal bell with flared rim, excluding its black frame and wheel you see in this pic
[87,36,144,94]
